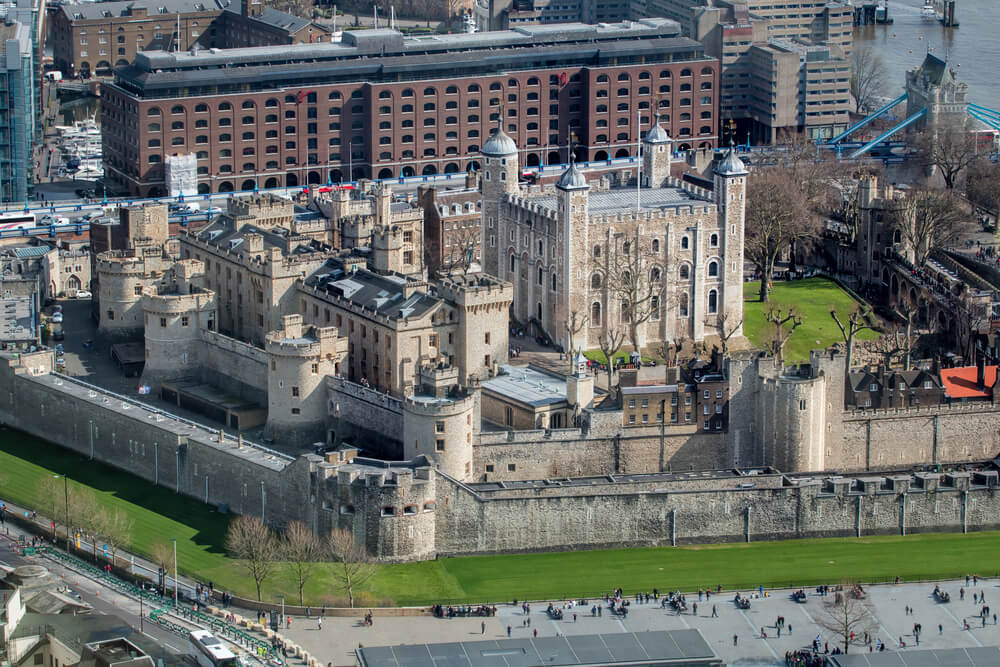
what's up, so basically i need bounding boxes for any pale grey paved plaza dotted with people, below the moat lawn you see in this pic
[282,580,1000,666]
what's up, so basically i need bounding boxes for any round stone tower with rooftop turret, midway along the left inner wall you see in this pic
[264,315,347,451]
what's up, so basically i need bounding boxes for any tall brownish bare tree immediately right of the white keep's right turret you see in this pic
[744,169,819,303]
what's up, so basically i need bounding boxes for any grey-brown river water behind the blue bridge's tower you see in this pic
[854,0,1000,110]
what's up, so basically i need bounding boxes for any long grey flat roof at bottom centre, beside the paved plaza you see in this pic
[357,630,722,667]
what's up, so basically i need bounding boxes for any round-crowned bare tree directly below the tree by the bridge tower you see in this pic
[892,188,969,268]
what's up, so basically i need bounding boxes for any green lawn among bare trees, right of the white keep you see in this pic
[743,278,878,362]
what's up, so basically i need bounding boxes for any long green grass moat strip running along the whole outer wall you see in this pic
[0,430,1000,605]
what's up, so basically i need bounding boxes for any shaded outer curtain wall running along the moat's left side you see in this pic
[0,352,314,525]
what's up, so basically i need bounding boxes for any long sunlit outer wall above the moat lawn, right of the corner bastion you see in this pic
[436,474,1000,556]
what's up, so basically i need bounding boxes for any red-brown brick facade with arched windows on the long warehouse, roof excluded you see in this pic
[101,58,719,195]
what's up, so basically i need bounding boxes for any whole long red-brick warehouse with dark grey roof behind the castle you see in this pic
[101,19,719,195]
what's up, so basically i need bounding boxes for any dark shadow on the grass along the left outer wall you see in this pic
[0,427,229,554]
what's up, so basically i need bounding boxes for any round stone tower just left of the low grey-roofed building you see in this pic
[403,366,479,482]
